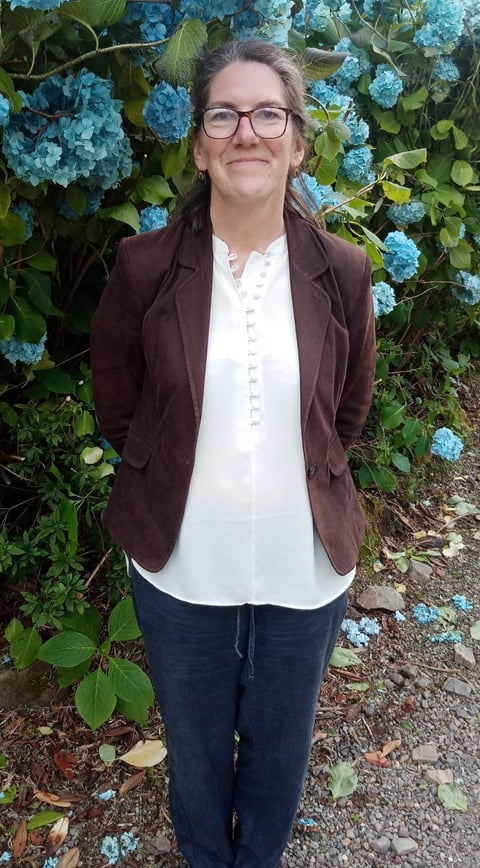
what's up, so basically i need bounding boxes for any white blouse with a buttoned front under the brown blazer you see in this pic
[134,235,355,609]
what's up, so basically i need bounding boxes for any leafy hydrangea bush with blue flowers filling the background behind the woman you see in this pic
[0,0,480,636]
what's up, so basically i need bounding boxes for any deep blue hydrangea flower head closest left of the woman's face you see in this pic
[143,81,191,143]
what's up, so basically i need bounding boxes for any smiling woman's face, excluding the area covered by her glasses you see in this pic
[193,61,304,210]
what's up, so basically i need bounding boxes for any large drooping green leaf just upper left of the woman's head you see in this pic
[155,18,208,85]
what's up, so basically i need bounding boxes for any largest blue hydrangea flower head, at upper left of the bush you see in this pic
[3,69,132,190]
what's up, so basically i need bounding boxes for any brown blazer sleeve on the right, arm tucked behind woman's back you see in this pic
[335,251,376,449]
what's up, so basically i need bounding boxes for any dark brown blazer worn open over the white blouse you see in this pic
[91,214,375,574]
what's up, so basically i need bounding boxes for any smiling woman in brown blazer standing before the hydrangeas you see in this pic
[92,40,375,868]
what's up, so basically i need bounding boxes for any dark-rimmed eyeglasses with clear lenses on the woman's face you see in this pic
[199,106,292,139]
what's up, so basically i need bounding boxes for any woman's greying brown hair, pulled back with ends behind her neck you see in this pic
[173,39,316,232]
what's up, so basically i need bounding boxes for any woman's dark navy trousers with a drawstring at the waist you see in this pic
[130,567,347,868]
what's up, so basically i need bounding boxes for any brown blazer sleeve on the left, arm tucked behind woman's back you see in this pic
[90,238,145,454]
